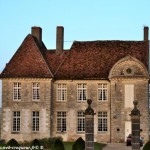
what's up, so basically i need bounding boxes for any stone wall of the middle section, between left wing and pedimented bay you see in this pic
[53,80,110,142]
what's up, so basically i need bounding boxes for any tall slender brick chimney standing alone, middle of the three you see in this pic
[56,26,64,55]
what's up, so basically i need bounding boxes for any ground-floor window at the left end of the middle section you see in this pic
[57,112,66,132]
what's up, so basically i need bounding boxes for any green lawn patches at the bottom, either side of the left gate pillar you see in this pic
[64,142,105,150]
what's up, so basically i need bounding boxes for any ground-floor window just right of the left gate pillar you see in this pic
[98,112,108,132]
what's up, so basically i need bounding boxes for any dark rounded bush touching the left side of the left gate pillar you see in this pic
[72,137,85,150]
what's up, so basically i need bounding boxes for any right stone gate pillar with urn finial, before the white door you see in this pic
[130,100,141,150]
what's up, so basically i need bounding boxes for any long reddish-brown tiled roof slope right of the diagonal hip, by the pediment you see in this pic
[51,41,148,79]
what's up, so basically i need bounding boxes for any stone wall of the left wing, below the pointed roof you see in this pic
[2,79,51,141]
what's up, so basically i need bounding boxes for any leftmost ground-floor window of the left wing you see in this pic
[12,111,20,132]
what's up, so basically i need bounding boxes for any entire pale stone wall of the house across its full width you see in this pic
[2,78,149,142]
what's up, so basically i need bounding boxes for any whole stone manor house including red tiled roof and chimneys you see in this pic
[0,27,149,142]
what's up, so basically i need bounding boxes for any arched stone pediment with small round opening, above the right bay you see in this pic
[109,56,148,79]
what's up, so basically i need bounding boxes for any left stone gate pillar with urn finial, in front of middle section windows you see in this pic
[85,99,95,150]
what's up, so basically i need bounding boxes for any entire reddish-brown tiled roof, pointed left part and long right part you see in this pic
[1,34,148,79]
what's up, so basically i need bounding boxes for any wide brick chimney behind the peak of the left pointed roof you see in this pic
[31,26,42,44]
